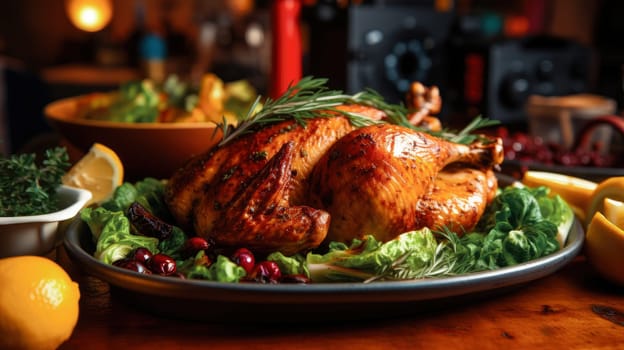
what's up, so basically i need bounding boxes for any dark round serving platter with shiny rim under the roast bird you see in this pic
[64,218,584,322]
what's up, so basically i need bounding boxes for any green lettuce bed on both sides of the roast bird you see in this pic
[81,174,574,282]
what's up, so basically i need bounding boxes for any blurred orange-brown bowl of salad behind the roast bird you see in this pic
[45,74,256,180]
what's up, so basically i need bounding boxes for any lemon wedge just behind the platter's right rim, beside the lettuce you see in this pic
[522,170,598,221]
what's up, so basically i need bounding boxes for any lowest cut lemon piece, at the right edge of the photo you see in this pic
[585,212,624,286]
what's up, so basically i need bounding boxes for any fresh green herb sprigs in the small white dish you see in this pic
[0,147,70,217]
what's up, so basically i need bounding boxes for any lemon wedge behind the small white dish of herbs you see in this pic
[62,143,124,205]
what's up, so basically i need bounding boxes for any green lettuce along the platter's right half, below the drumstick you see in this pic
[276,187,574,282]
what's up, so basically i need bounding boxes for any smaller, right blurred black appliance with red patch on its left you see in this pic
[443,36,592,129]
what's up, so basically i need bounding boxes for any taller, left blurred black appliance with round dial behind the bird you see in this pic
[302,0,453,107]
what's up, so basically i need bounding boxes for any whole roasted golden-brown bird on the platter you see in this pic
[165,85,502,254]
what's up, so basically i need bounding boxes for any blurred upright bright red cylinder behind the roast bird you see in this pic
[270,0,302,98]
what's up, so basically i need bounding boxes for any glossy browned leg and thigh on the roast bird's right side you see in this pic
[310,124,502,241]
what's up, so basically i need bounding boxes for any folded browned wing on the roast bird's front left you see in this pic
[207,142,329,254]
